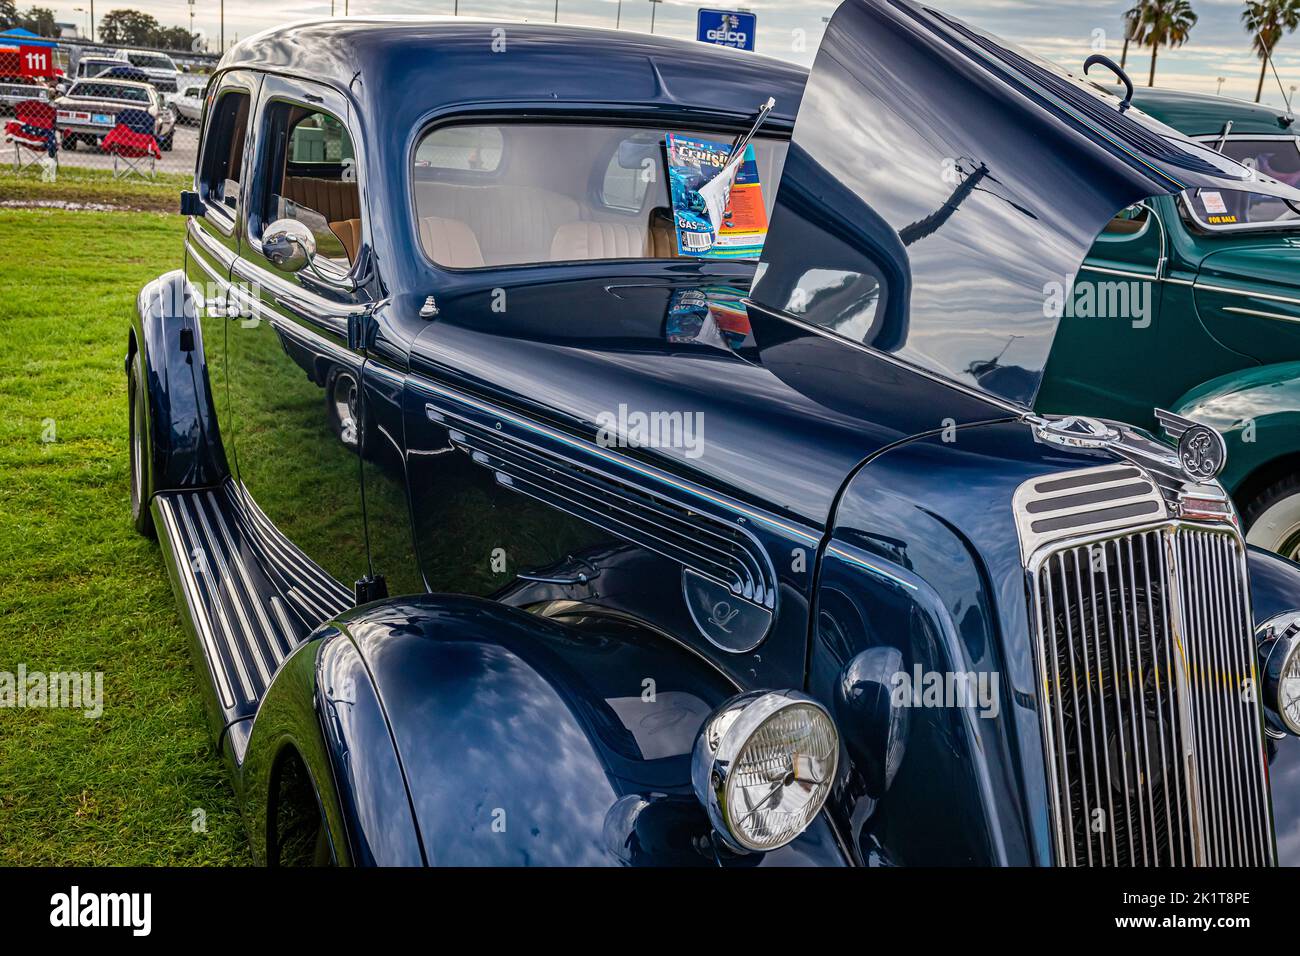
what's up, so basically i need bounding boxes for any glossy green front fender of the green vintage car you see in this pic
[1170,362,1300,496]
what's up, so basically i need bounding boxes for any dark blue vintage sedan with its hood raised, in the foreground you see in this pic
[126,0,1300,866]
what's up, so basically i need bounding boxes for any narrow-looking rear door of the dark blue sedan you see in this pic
[185,70,259,478]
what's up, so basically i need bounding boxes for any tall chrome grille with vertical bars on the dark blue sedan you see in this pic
[1030,524,1274,866]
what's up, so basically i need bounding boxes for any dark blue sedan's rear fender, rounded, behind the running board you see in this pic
[126,269,229,490]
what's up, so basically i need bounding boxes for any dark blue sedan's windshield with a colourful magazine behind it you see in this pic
[412,124,788,268]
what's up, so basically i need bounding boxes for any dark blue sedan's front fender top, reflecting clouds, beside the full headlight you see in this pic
[335,596,842,866]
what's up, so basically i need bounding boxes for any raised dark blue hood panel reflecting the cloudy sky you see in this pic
[753,0,1297,407]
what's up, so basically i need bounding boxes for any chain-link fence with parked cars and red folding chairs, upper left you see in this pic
[0,36,217,184]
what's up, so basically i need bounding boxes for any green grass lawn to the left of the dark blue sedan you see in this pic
[0,209,250,865]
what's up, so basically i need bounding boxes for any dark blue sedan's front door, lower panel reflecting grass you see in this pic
[226,77,371,598]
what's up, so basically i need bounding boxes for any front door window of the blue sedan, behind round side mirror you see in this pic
[255,101,361,269]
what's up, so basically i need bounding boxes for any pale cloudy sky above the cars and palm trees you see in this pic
[50,0,1300,104]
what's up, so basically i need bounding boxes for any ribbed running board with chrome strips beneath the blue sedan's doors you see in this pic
[152,481,352,726]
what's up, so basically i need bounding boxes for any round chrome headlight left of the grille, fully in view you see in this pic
[690,691,840,852]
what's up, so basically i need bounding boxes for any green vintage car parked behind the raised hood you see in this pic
[1039,90,1300,559]
